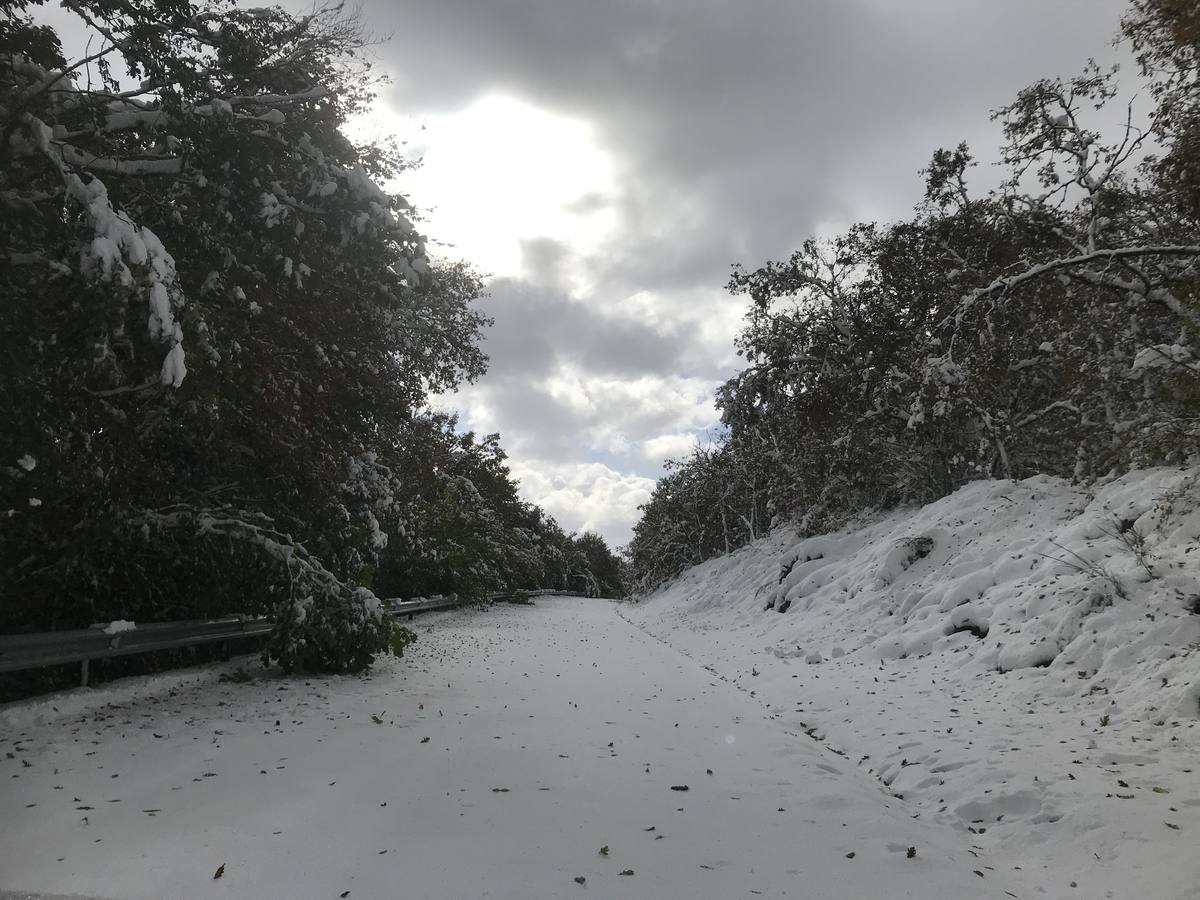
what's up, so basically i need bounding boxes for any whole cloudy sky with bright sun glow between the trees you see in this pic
[350,0,1123,544]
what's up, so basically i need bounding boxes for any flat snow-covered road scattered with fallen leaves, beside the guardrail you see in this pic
[0,598,1016,900]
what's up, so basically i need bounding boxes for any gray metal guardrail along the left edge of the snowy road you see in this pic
[0,594,480,686]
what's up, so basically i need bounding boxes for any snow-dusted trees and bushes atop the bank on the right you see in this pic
[631,0,1200,587]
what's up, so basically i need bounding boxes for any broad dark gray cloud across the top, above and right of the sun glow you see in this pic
[368,0,1122,289]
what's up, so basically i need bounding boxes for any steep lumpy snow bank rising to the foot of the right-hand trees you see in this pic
[638,469,1200,721]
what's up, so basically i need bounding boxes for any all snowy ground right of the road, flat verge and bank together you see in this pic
[623,469,1200,900]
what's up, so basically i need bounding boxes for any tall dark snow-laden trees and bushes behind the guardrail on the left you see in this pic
[0,0,611,670]
